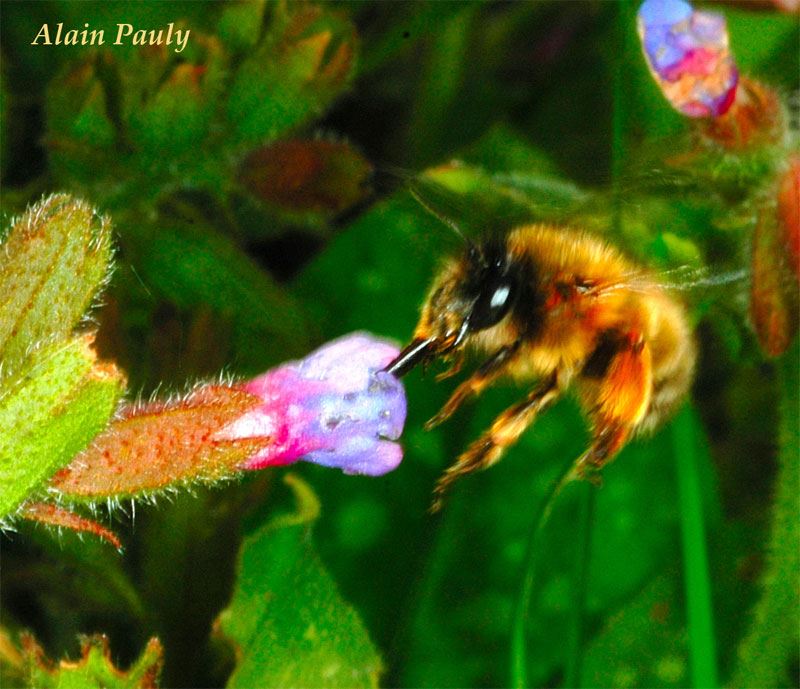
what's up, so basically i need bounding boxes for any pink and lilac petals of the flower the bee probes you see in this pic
[215,333,406,476]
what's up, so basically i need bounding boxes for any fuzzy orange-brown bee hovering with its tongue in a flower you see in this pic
[386,224,697,511]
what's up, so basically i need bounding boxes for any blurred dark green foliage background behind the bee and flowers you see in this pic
[0,2,800,687]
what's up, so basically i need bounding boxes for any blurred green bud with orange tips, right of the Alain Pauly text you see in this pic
[228,3,355,142]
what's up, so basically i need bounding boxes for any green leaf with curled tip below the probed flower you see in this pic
[219,477,381,687]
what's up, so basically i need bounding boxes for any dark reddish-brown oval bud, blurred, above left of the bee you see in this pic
[240,139,372,216]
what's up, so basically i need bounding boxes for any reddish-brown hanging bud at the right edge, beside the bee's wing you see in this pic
[750,198,800,356]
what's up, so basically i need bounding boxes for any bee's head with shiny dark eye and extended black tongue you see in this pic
[386,241,519,377]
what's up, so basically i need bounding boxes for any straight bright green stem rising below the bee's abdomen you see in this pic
[672,405,718,689]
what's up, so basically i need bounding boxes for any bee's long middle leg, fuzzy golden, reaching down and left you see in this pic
[431,372,562,512]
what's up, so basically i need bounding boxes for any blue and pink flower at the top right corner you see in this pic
[637,0,739,117]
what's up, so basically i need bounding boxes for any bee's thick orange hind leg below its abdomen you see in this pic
[572,332,653,482]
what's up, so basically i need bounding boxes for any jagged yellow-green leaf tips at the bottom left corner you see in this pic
[23,636,164,689]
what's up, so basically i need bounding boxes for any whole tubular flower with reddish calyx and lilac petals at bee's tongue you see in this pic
[50,333,406,501]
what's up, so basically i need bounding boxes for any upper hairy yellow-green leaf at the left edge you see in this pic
[0,194,111,376]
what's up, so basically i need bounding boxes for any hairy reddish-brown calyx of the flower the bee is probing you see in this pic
[50,386,270,501]
